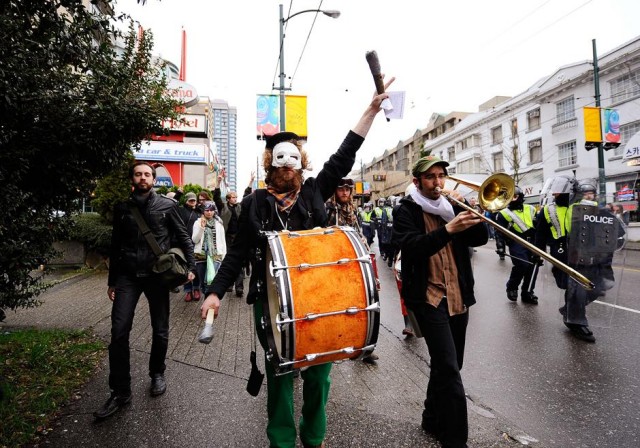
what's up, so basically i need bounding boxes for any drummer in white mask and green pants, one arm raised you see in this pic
[201,79,393,447]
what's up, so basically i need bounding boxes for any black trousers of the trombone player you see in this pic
[413,299,469,447]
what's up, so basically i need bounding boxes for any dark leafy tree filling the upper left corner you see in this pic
[0,0,178,309]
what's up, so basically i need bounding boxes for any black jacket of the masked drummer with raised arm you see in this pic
[207,132,364,303]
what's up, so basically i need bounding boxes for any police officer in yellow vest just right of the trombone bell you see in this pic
[497,186,538,305]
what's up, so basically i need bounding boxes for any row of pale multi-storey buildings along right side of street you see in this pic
[360,37,640,221]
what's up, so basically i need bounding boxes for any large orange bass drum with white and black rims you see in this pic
[262,227,380,375]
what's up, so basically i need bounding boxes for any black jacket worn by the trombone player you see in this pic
[392,196,489,308]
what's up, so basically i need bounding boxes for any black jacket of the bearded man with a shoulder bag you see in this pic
[108,190,196,286]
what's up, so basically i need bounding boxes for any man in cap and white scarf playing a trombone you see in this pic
[392,155,489,448]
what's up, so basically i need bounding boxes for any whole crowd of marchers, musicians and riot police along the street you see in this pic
[94,94,624,447]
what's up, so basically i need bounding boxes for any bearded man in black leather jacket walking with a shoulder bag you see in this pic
[93,162,196,419]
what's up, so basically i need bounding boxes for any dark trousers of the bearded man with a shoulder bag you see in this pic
[109,275,169,394]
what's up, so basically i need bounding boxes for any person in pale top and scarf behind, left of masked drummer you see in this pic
[192,201,227,291]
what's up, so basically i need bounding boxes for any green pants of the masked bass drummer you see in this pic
[254,300,332,448]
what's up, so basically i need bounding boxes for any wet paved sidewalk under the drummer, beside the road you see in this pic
[0,273,542,448]
